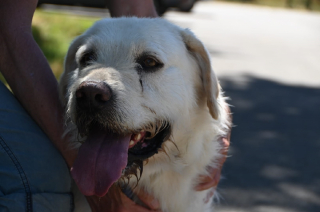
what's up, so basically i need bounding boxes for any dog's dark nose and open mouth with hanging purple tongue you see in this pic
[71,81,171,197]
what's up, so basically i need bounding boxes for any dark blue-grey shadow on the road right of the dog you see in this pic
[219,76,320,212]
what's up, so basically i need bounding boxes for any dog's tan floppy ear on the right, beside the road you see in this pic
[181,29,220,119]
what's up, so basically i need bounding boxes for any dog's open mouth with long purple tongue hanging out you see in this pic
[71,122,171,197]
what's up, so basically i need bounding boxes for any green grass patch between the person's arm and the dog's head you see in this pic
[0,9,99,84]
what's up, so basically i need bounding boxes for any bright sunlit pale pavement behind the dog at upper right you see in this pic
[165,2,320,86]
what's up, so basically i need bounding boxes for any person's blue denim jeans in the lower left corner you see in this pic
[0,82,74,212]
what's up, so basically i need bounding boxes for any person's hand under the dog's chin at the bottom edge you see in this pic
[86,186,161,212]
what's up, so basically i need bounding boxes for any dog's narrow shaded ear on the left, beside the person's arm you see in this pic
[59,36,84,104]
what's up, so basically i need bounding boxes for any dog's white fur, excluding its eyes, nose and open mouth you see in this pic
[60,18,230,212]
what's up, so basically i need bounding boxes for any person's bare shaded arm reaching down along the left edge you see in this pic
[0,0,77,167]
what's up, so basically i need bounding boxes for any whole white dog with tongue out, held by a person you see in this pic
[59,17,231,212]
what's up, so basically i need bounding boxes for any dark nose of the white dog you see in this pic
[76,81,112,109]
